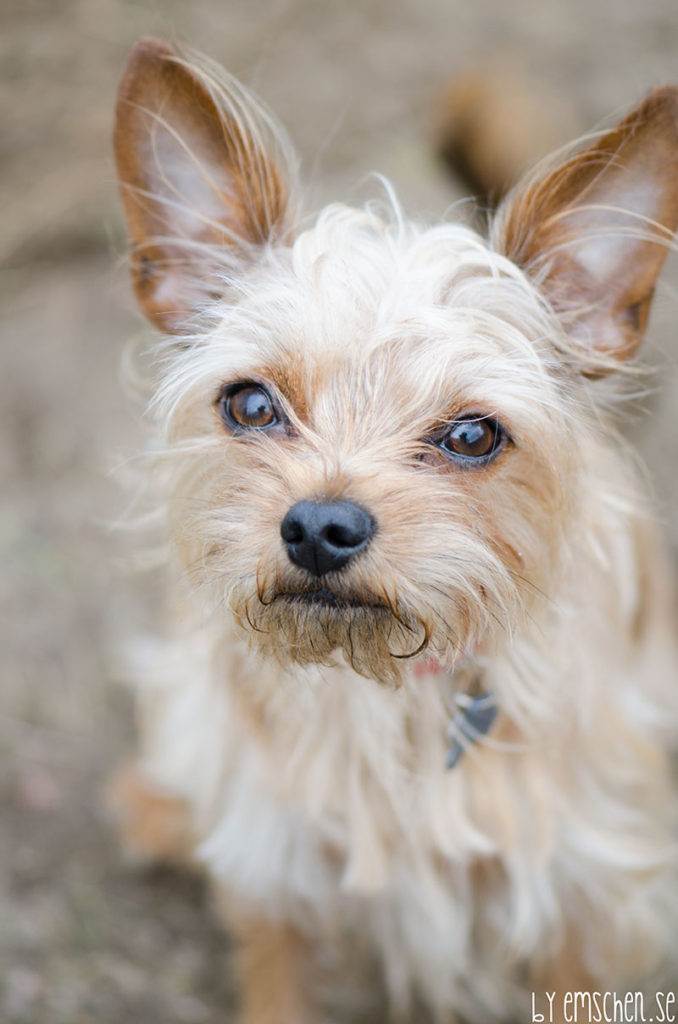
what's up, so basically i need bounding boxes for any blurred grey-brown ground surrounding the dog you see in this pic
[0,0,678,1024]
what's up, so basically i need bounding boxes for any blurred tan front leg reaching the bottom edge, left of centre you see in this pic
[228,915,321,1024]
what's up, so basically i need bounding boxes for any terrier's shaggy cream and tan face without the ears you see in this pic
[153,222,577,678]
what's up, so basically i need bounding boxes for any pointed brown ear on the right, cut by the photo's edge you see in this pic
[493,86,678,376]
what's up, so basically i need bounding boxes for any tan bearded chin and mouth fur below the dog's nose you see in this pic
[236,587,428,685]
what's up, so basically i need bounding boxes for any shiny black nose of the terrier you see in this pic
[281,502,376,575]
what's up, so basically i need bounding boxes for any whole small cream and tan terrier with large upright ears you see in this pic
[115,39,678,1024]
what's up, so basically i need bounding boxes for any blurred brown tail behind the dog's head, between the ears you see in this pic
[436,60,577,209]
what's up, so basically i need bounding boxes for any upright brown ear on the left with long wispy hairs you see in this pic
[114,39,294,332]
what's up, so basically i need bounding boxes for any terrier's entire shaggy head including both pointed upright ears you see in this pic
[117,42,678,680]
